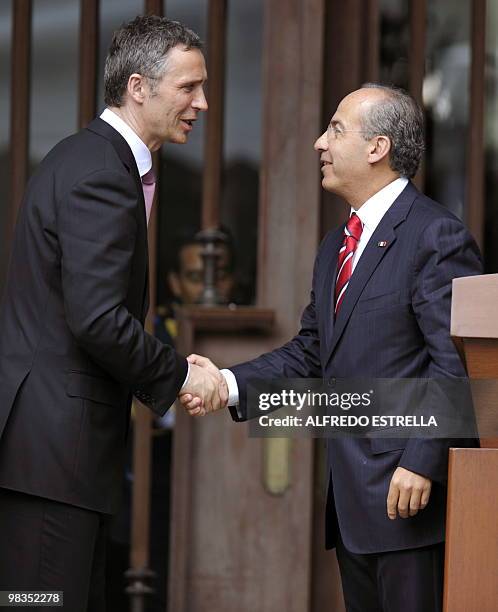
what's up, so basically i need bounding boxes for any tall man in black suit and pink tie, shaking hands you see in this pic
[0,17,226,612]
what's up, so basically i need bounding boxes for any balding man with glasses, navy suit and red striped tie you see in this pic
[182,84,481,612]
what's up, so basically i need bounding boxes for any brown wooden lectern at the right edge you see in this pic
[444,274,498,612]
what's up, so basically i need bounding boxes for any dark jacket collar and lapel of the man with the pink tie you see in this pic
[86,117,149,321]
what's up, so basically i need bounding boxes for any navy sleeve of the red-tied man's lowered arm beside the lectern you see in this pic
[399,218,482,482]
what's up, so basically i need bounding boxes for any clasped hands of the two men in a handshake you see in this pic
[178,355,228,416]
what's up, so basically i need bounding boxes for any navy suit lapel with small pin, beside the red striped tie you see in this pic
[327,183,418,363]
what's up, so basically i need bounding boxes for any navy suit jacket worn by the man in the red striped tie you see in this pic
[231,183,481,553]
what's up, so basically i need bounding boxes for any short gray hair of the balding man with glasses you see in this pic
[361,83,425,178]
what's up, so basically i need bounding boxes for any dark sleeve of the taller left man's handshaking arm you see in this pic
[57,170,187,414]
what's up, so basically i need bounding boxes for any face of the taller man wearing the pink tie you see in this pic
[143,46,207,144]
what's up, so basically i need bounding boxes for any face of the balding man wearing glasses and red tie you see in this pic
[315,90,378,196]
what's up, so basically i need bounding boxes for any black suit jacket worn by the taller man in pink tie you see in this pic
[0,119,187,512]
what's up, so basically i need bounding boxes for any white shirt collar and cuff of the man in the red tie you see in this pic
[221,177,408,406]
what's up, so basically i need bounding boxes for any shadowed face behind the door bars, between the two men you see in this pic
[169,244,233,304]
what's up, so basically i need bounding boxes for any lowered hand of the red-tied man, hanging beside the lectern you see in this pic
[387,467,432,520]
